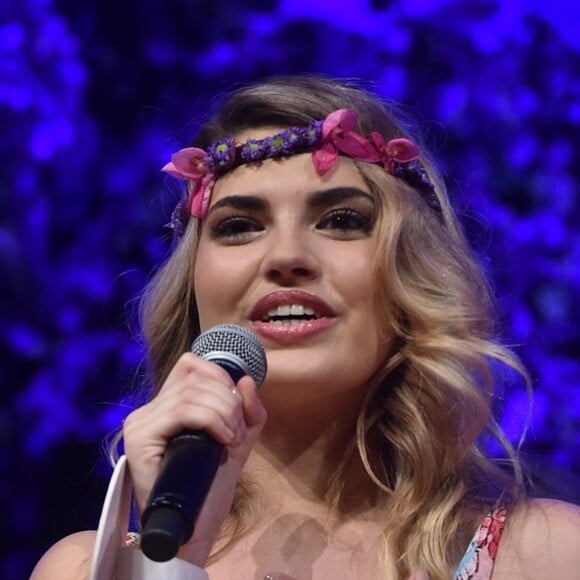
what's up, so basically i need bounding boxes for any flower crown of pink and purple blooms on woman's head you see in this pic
[162,109,441,236]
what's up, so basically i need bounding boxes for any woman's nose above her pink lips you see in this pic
[262,227,320,286]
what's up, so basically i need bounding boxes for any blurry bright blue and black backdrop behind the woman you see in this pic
[0,0,580,579]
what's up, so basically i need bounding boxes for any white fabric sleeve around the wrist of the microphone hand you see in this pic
[88,455,209,580]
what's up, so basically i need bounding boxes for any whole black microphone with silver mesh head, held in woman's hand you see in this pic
[141,324,267,562]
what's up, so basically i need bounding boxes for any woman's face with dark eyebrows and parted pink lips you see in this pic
[194,130,389,396]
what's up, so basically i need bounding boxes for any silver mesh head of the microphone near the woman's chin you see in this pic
[191,324,268,387]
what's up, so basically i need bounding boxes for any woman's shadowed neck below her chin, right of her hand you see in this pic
[246,391,377,518]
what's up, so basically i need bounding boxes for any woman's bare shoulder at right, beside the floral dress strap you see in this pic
[493,499,580,580]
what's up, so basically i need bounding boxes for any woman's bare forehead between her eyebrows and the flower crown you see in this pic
[210,127,370,205]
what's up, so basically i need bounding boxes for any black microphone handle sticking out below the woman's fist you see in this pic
[141,430,224,562]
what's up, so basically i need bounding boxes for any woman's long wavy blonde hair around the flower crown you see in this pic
[136,77,529,580]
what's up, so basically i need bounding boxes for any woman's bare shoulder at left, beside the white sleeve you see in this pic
[30,531,97,580]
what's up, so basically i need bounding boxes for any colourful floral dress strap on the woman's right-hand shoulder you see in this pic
[453,505,507,580]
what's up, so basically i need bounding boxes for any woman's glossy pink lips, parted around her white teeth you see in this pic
[250,290,336,344]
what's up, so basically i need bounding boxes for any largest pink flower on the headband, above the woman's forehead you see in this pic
[312,109,381,174]
